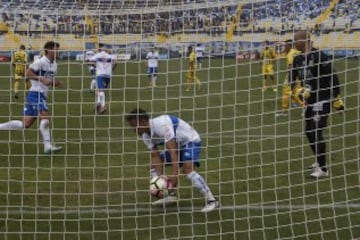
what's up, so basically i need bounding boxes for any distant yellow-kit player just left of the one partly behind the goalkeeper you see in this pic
[260,41,277,92]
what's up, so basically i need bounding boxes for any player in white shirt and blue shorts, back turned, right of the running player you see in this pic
[89,43,116,114]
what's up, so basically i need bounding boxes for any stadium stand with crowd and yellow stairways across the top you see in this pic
[0,0,360,49]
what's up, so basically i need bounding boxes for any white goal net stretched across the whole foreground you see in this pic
[0,0,360,240]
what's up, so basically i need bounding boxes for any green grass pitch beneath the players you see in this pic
[0,55,360,240]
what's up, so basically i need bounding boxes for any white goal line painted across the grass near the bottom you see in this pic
[0,203,360,215]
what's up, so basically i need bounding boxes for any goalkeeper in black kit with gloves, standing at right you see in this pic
[290,31,344,178]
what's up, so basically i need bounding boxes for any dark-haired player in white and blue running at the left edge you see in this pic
[0,42,63,154]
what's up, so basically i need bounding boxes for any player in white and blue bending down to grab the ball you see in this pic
[126,109,219,212]
